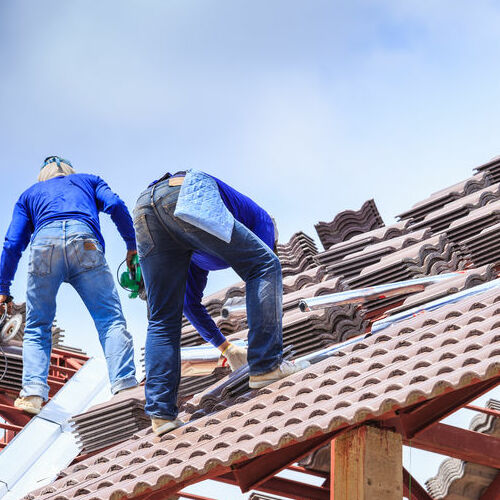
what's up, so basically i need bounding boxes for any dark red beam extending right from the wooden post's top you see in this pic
[404,424,500,469]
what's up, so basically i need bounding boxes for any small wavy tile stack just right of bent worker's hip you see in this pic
[277,231,318,278]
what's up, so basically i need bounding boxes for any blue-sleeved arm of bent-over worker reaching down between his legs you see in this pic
[184,263,226,347]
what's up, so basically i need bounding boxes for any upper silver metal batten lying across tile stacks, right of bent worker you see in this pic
[299,272,463,312]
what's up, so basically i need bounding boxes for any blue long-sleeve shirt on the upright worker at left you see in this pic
[0,174,136,295]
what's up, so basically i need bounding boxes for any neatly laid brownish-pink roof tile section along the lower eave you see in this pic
[27,282,500,500]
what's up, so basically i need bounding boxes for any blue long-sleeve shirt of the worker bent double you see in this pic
[179,177,274,347]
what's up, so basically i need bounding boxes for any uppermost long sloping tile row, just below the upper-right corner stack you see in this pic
[397,172,494,222]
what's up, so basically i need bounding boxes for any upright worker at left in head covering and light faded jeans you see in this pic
[0,156,137,414]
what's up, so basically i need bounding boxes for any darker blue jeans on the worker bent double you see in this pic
[134,181,283,420]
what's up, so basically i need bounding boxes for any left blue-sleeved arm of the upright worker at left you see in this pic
[0,197,33,302]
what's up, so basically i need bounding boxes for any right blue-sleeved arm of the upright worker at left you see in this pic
[95,177,136,251]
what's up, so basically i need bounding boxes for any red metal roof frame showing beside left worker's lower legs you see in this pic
[0,348,88,450]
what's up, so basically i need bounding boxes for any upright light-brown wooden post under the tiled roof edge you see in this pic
[332,425,403,500]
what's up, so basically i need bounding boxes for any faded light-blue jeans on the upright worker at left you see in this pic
[21,220,137,401]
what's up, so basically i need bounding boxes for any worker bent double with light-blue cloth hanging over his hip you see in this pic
[134,170,308,435]
